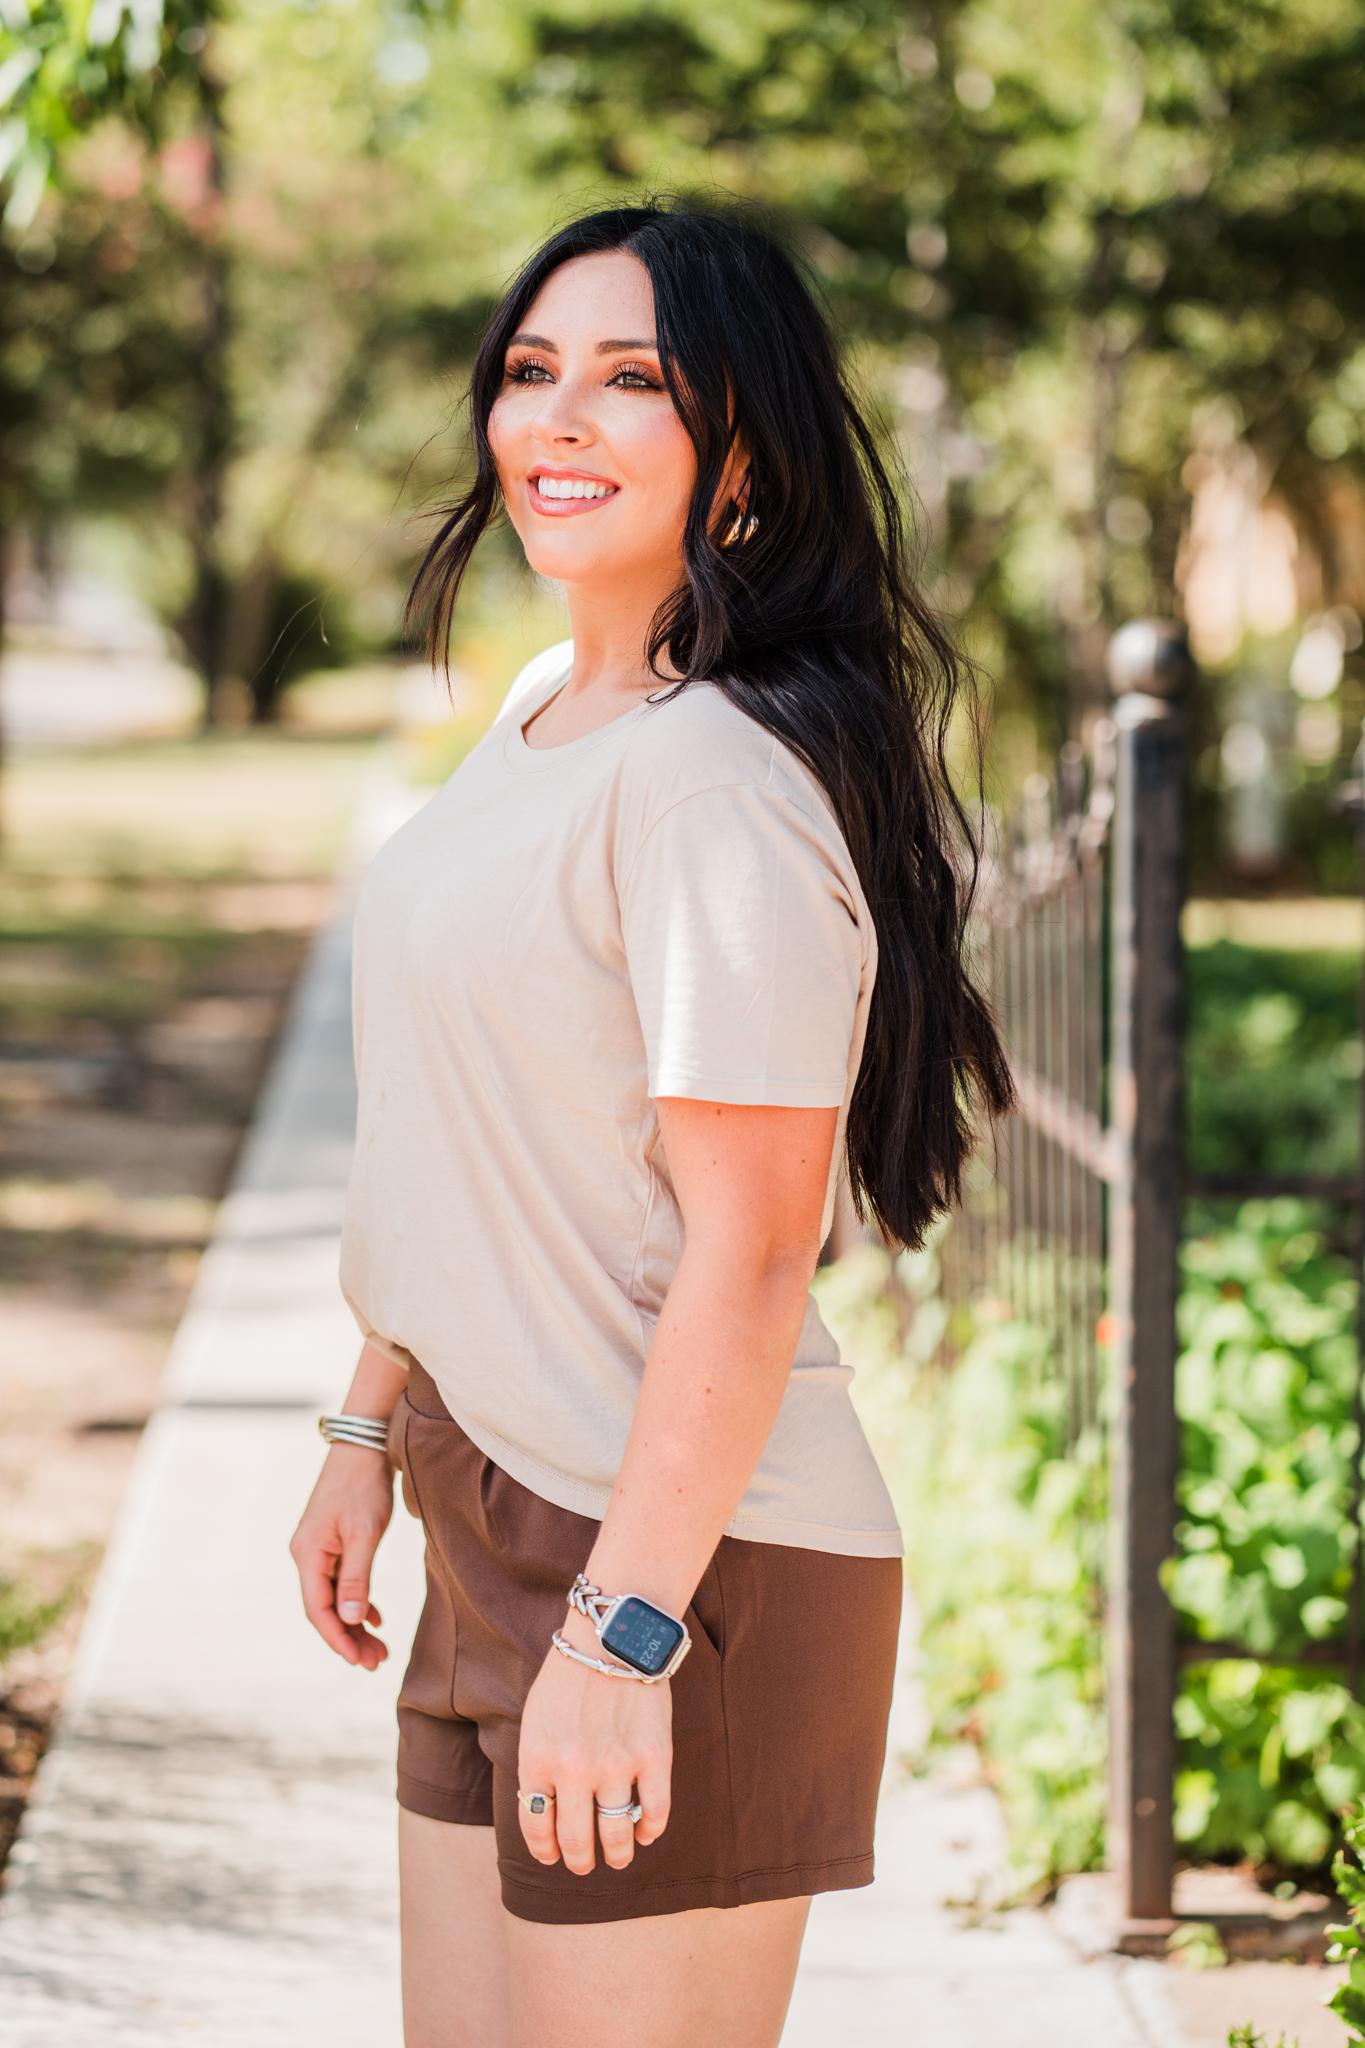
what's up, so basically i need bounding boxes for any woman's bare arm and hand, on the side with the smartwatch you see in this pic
[518,1096,837,1874]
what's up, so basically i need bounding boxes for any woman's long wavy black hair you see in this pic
[403,199,1015,1249]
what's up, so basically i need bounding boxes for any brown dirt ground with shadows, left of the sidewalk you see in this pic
[0,864,332,1870]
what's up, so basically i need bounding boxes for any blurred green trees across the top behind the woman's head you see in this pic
[0,0,1365,847]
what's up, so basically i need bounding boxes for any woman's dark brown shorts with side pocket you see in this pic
[389,1364,900,1921]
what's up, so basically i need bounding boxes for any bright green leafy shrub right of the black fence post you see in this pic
[1162,1200,1365,1874]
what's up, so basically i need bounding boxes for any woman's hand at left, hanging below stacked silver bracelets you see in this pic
[289,1444,393,1671]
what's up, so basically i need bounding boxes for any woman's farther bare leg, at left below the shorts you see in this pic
[397,1806,512,2048]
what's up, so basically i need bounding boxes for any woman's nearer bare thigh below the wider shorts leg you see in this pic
[505,1898,810,2048]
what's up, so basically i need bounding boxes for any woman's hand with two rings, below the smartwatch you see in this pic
[518,1612,673,1876]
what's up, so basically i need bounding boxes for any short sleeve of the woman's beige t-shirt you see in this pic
[620,782,866,1108]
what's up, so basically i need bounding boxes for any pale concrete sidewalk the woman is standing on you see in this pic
[0,756,1181,2048]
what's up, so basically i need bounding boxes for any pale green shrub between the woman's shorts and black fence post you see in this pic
[817,1247,1105,1892]
